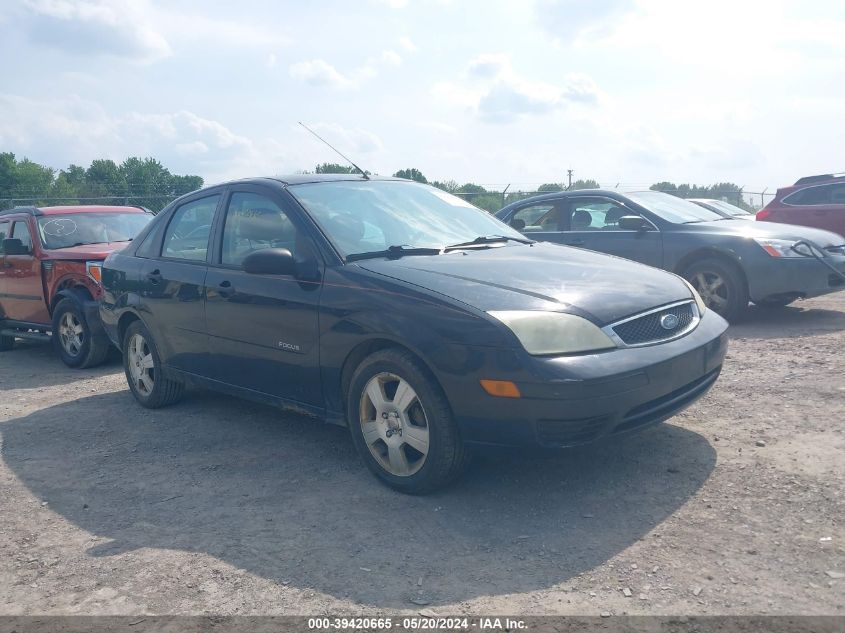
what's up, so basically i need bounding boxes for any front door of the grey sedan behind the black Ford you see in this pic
[560,196,663,268]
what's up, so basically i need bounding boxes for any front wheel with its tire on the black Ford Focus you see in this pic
[346,349,469,494]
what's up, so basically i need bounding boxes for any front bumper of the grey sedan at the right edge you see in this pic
[746,255,845,301]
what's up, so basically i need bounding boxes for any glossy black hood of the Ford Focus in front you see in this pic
[356,242,692,325]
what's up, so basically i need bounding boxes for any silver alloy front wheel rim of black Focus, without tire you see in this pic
[359,372,430,477]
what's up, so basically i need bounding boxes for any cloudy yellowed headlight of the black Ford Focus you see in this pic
[488,310,616,355]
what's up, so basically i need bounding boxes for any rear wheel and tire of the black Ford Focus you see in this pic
[122,321,185,409]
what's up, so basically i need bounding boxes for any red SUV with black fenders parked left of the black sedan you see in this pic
[0,206,153,367]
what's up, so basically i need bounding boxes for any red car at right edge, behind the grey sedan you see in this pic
[757,174,845,237]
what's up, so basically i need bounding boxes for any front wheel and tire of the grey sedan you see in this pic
[683,257,748,321]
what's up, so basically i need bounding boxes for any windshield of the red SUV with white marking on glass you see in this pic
[38,212,153,248]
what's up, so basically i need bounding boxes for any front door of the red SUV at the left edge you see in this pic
[0,218,50,324]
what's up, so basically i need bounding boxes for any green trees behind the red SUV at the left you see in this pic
[0,152,203,211]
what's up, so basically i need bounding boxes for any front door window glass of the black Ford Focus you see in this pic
[220,192,297,266]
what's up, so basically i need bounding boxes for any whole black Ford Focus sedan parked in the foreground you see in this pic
[100,175,727,493]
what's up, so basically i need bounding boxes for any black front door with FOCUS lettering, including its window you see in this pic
[206,186,322,406]
